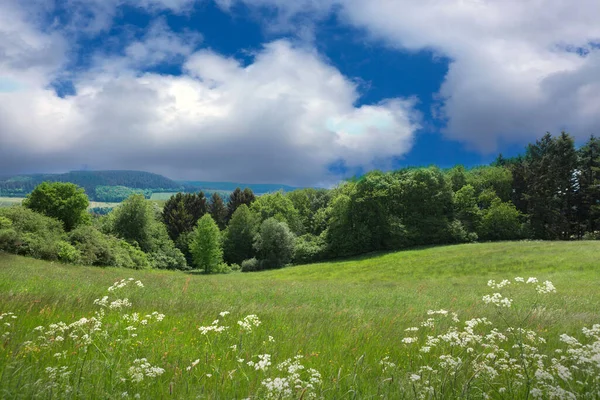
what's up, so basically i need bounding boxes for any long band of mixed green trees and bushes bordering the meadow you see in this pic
[0,132,600,272]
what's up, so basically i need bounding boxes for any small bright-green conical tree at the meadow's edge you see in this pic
[190,214,223,274]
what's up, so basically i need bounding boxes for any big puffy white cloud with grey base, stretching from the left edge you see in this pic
[0,2,419,184]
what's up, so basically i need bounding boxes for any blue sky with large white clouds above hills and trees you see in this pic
[0,0,600,186]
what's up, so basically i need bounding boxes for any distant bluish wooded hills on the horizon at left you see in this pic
[0,170,296,202]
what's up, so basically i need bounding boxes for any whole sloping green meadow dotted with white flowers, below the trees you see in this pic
[0,242,600,399]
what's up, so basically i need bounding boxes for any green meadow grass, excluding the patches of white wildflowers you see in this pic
[0,242,600,399]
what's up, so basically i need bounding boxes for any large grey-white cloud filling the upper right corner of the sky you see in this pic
[223,0,600,151]
